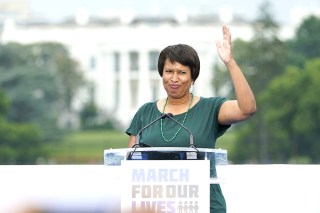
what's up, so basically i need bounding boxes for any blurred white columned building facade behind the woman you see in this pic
[1,19,252,128]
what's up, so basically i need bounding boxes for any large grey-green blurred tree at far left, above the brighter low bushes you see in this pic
[0,43,84,140]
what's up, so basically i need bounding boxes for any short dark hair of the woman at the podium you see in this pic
[158,44,200,81]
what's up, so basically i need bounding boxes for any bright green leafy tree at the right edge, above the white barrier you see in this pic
[261,58,320,163]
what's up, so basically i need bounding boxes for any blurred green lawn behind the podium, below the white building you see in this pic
[47,130,235,164]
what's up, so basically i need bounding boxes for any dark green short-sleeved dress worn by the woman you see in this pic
[126,97,230,213]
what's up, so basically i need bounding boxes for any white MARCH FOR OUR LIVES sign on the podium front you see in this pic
[121,160,210,213]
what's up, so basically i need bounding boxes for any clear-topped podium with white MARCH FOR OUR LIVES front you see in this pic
[104,147,228,213]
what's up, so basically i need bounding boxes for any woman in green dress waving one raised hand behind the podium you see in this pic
[126,26,256,213]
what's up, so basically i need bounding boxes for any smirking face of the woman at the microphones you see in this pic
[162,59,192,98]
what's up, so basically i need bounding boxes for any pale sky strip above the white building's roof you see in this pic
[29,0,320,22]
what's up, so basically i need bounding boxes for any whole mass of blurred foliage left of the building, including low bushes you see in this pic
[0,43,84,164]
